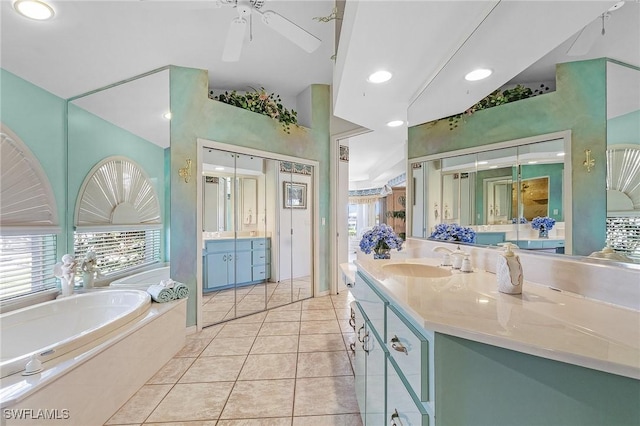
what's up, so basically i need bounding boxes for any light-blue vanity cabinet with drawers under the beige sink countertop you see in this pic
[350,267,640,426]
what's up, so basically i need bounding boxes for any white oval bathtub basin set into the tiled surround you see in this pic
[0,289,151,377]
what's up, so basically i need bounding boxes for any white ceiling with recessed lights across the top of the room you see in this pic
[0,0,640,187]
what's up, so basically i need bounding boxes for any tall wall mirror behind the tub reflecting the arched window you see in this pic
[66,68,171,284]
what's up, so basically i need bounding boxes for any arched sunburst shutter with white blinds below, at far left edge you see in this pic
[0,123,60,301]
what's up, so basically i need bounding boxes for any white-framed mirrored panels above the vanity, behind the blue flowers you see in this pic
[411,132,571,253]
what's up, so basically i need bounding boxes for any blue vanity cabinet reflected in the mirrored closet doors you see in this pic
[202,238,271,291]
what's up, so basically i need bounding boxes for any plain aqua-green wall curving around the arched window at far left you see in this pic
[0,69,67,253]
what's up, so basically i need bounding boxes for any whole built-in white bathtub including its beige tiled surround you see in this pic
[0,287,187,426]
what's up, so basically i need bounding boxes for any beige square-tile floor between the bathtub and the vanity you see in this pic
[106,291,362,426]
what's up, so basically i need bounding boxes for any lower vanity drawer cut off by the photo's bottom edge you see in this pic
[385,358,430,426]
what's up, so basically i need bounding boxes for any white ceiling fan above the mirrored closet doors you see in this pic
[218,0,322,62]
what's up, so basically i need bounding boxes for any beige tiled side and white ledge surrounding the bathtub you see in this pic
[0,299,186,426]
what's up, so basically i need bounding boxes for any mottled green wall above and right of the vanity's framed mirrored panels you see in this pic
[408,58,607,255]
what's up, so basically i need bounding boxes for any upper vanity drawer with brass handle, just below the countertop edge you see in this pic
[386,305,433,401]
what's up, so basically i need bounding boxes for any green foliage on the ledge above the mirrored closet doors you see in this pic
[209,87,300,133]
